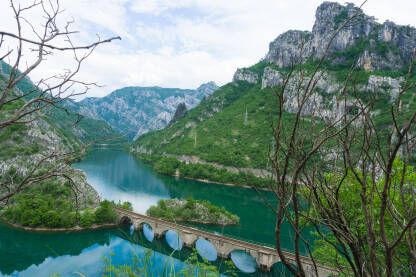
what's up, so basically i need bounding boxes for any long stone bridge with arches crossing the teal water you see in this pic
[115,208,336,276]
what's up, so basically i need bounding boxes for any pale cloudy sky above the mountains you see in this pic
[0,0,416,98]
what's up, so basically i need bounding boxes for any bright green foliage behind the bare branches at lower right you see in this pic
[306,159,416,276]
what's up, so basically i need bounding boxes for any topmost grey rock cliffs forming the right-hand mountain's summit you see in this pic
[265,2,416,70]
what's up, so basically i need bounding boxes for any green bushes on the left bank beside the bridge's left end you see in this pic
[2,176,132,228]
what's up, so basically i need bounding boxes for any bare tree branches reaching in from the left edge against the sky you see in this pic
[0,0,120,201]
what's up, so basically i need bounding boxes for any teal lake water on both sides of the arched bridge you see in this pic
[0,149,300,277]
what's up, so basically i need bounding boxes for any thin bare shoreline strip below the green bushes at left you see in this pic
[0,216,119,233]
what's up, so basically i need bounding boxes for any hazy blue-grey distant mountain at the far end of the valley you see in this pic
[71,82,218,139]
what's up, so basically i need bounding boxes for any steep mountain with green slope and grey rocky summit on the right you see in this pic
[133,2,416,169]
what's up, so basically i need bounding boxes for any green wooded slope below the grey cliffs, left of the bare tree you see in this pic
[135,81,286,168]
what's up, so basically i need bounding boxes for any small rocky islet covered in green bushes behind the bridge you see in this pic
[146,198,240,225]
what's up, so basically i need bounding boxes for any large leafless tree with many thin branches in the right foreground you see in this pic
[254,1,416,276]
